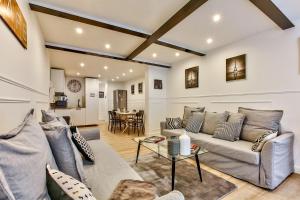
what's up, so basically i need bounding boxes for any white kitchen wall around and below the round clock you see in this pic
[65,76,85,108]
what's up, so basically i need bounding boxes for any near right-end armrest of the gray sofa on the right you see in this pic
[260,132,294,189]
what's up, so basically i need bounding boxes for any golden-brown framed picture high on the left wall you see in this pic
[0,0,27,49]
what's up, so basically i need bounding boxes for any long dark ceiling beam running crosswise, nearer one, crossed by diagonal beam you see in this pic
[29,3,205,56]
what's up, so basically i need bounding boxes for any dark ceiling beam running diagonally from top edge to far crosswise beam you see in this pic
[127,0,208,59]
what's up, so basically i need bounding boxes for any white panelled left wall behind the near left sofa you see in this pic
[0,0,50,131]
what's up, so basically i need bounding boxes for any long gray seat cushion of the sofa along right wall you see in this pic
[163,129,260,165]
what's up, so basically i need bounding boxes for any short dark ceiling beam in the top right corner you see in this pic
[249,0,295,30]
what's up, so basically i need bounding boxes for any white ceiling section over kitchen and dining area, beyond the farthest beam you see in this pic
[48,49,146,82]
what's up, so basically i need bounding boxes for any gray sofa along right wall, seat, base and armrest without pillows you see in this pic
[161,122,294,190]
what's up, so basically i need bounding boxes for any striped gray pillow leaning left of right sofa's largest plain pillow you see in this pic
[213,122,241,142]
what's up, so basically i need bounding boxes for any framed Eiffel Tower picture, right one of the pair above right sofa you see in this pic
[226,54,246,81]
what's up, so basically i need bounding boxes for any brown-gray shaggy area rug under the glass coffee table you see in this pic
[129,154,236,200]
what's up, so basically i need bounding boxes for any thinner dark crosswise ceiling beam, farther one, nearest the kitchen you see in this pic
[45,44,171,68]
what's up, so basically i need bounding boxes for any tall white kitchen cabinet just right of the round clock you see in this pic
[85,78,99,125]
